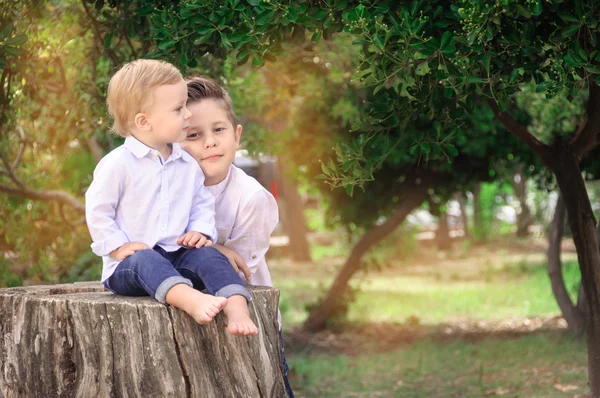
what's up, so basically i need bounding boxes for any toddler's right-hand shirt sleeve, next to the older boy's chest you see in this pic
[186,173,218,243]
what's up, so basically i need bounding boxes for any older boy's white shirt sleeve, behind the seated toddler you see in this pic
[223,190,279,275]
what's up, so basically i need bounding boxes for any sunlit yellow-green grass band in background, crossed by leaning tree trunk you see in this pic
[275,261,579,327]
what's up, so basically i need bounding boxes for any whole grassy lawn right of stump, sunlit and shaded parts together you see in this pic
[273,238,589,397]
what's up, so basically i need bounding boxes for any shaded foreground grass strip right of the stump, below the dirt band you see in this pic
[289,334,588,398]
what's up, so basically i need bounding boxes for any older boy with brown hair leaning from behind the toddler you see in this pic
[181,77,294,398]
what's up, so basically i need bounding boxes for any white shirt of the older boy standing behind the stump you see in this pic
[207,165,279,286]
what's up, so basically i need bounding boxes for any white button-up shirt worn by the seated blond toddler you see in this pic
[85,136,217,282]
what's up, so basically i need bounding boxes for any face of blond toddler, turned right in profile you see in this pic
[138,80,191,147]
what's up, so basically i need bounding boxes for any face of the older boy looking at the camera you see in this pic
[181,99,242,185]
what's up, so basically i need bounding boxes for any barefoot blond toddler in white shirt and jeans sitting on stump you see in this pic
[86,59,258,335]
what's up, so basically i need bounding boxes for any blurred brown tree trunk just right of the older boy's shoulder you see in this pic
[277,157,312,261]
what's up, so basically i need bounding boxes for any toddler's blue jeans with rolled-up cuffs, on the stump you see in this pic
[104,245,251,304]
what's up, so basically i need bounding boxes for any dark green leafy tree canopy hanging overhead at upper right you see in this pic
[135,0,600,189]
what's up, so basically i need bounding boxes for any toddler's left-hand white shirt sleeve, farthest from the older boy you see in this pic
[85,158,129,256]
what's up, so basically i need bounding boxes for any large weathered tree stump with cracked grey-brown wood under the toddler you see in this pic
[0,282,286,398]
